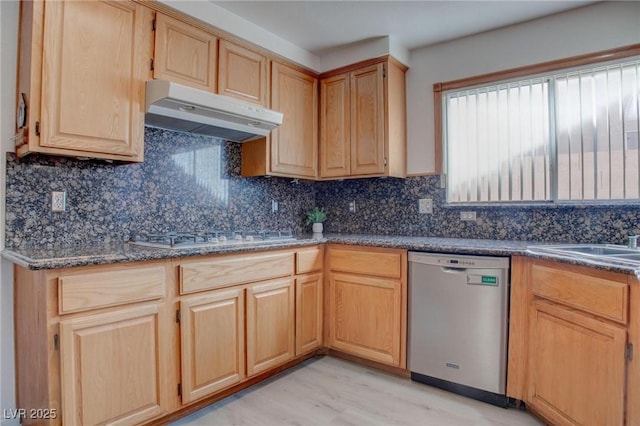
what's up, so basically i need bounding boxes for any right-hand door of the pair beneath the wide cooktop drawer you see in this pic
[247,278,295,376]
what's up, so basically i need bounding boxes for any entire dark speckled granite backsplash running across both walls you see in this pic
[6,128,640,248]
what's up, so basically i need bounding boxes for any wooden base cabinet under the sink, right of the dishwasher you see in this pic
[507,256,640,425]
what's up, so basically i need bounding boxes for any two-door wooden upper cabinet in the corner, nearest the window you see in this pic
[320,57,406,179]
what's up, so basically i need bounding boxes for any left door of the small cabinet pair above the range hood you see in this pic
[153,13,218,93]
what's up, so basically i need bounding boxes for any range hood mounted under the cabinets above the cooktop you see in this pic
[145,80,283,142]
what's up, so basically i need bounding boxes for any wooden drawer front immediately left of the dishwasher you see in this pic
[329,248,402,278]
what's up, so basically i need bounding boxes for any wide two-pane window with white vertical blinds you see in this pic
[441,58,640,204]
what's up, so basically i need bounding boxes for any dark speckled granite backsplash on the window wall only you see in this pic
[316,176,640,244]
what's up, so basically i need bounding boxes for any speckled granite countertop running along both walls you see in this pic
[2,233,640,278]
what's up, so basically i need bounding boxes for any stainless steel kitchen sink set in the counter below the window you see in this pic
[527,244,640,266]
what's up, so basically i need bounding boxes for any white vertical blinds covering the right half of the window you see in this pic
[554,61,640,200]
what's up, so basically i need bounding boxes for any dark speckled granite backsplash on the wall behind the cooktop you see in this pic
[6,128,315,247]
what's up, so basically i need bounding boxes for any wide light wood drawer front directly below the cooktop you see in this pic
[180,252,294,294]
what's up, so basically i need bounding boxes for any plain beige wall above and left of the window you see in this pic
[407,2,640,174]
